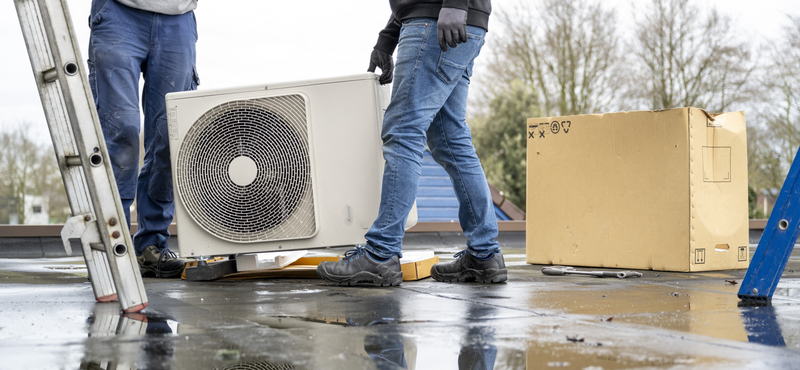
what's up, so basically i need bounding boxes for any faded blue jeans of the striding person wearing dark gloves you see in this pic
[366,18,500,258]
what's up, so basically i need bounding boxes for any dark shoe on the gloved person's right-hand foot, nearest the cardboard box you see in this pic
[431,250,508,283]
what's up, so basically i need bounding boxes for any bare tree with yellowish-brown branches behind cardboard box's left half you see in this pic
[482,0,622,115]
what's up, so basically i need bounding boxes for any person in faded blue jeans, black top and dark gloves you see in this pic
[317,0,507,286]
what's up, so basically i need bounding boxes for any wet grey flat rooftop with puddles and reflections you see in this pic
[0,244,800,370]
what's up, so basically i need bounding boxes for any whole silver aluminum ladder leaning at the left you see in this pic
[14,0,147,312]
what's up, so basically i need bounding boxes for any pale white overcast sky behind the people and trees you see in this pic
[0,0,800,145]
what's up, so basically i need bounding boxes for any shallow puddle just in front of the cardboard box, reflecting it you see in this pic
[529,282,800,348]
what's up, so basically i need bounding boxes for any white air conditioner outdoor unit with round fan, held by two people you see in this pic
[166,73,417,257]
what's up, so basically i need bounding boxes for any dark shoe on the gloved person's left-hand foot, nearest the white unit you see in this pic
[317,247,403,286]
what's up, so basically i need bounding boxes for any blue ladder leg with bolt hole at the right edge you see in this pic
[739,152,800,304]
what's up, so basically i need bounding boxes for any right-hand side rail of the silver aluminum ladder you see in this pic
[39,0,147,311]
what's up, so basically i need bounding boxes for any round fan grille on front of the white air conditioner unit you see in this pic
[176,95,316,242]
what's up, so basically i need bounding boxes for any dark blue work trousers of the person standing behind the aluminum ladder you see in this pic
[88,0,198,254]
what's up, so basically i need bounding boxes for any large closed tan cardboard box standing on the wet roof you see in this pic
[526,108,749,271]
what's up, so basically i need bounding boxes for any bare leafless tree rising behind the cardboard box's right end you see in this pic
[632,0,756,112]
